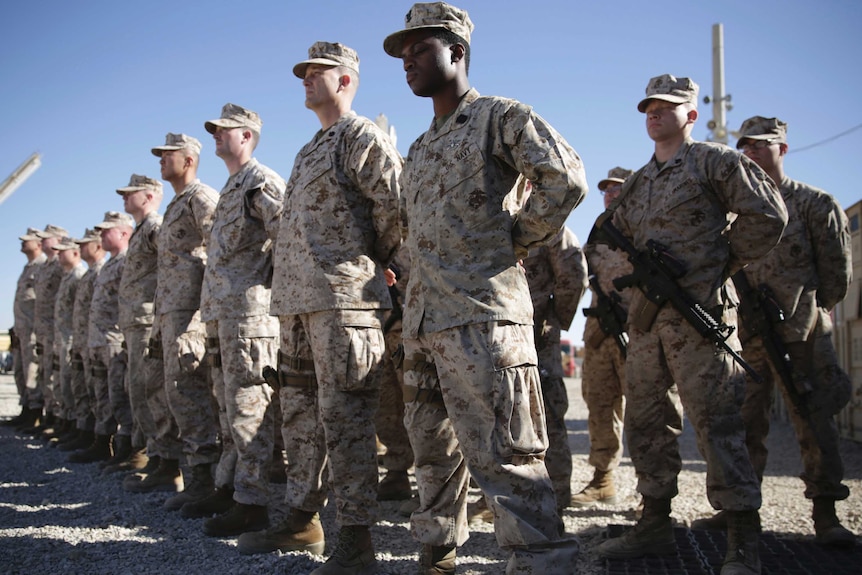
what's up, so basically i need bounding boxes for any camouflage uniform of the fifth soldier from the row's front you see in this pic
[118,205,181,459]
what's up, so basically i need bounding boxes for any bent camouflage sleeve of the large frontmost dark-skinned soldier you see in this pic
[502,103,588,251]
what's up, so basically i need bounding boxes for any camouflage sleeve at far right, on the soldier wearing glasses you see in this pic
[808,192,853,310]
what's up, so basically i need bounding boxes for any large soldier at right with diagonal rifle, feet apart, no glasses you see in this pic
[598,74,787,575]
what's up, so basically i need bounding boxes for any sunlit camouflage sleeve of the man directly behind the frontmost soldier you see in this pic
[348,126,403,266]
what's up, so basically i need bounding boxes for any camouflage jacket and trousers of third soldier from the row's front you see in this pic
[201,158,285,506]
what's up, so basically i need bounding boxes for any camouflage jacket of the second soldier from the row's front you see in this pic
[271,112,402,315]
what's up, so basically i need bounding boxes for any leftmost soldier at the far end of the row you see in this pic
[9,228,48,428]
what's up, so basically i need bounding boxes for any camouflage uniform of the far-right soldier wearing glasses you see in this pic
[741,176,852,500]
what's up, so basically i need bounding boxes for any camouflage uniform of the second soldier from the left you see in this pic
[30,233,65,414]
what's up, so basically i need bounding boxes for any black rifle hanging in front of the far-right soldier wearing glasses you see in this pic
[732,270,810,417]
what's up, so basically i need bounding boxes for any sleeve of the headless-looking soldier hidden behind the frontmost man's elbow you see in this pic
[548,227,587,329]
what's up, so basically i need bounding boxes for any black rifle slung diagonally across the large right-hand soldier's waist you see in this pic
[596,211,763,382]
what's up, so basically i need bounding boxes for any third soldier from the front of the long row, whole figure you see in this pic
[180,104,285,537]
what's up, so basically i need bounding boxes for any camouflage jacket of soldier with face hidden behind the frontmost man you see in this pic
[523,227,587,377]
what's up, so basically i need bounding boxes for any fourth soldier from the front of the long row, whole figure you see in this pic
[150,133,219,510]
